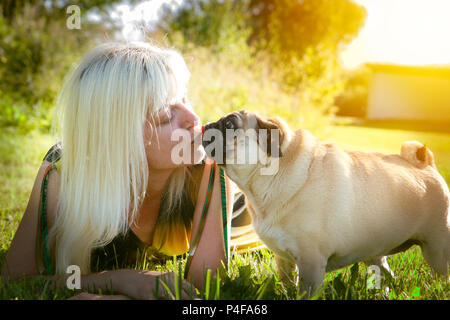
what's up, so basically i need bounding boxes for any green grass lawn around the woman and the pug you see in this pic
[0,125,450,300]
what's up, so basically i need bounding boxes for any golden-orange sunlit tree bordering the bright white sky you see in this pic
[248,0,367,118]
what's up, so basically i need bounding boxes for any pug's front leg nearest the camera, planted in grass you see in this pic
[296,253,327,299]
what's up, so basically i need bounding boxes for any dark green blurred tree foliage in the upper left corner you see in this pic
[0,0,139,130]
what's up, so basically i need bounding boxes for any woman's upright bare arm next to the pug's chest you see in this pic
[187,159,233,289]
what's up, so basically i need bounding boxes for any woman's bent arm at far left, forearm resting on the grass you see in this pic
[1,161,195,299]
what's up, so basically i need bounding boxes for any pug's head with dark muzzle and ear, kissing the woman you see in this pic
[203,110,289,180]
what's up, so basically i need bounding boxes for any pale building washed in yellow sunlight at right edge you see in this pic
[366,64,450,121]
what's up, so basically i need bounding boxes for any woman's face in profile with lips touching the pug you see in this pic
[144,97,205,170]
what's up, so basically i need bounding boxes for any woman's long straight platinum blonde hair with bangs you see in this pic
[49,42,190,274]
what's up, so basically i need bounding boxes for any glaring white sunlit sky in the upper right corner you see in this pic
[341,0,450,68]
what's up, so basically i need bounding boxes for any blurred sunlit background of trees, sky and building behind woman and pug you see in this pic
[0,0,450,242]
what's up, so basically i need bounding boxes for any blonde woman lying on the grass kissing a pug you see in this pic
[2,42,260,299]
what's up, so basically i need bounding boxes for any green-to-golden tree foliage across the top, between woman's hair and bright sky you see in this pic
[160,0,366,127]
